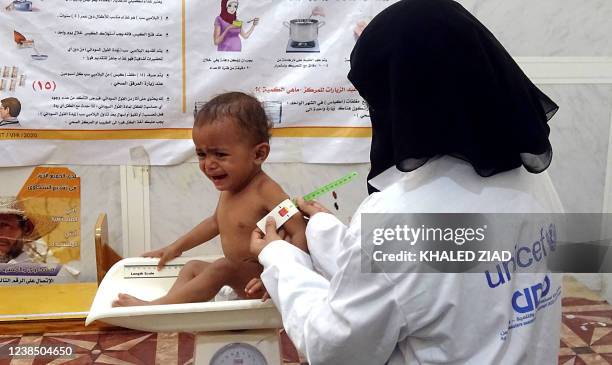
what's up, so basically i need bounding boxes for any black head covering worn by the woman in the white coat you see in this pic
[348,0,558,193]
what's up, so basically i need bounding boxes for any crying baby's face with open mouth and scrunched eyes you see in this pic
[193,120,260,191]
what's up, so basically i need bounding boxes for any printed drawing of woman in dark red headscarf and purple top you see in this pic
[213,0,259,52]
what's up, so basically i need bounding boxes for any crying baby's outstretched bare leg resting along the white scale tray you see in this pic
[113,258,244,306]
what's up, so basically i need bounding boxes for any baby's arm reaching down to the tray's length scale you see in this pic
[143,212,219,269]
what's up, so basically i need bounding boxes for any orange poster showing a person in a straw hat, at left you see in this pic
[0,167,81,285]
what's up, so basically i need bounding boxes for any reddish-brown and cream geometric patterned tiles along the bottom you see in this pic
[0,278,612,365]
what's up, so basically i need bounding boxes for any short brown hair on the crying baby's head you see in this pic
[193,91,272,144]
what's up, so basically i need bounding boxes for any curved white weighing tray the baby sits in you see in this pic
[85,256,282,332]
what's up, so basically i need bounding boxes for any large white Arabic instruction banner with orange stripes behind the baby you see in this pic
[0,0,394,166]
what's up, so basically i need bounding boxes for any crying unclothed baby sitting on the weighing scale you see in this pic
[113,92,307,306]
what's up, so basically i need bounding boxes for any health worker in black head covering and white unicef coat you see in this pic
[251,0,562,365]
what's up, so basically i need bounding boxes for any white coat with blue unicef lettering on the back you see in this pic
[259,157,562,365]
